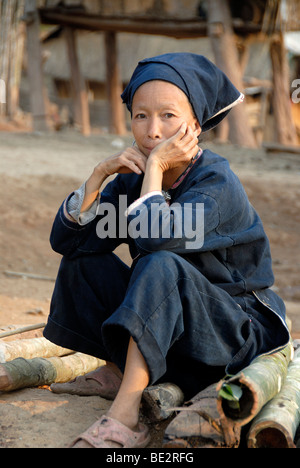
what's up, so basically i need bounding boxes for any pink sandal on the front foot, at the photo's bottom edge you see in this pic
[71,415,151,448]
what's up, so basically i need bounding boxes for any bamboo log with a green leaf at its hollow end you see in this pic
[217,343,293,426]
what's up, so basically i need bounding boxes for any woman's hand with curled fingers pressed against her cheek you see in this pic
[148,123,199,172]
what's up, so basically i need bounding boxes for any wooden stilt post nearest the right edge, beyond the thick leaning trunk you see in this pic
[270,33,298,145]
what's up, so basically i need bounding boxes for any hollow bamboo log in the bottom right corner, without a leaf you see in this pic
[247,349,300,448]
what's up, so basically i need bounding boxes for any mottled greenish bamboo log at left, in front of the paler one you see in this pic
[0,353,105,392]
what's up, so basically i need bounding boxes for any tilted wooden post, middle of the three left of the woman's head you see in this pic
[65,27,91,136]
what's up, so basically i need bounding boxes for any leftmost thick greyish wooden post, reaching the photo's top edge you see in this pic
[24,0,48,131]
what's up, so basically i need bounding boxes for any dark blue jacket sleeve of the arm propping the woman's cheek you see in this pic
[128,166,265,254]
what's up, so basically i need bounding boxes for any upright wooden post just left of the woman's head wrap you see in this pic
[105,31,126,135]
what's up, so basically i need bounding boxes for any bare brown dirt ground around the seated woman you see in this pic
[0,131,300,448]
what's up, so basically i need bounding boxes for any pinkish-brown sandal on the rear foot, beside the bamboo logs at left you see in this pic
[50,366,121,400]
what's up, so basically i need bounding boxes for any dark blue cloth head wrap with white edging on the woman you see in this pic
[121,52,244,132]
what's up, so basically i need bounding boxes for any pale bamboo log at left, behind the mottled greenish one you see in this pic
[0,337,73,363]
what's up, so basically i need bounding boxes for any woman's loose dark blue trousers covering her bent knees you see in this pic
[44,251,282,397]
